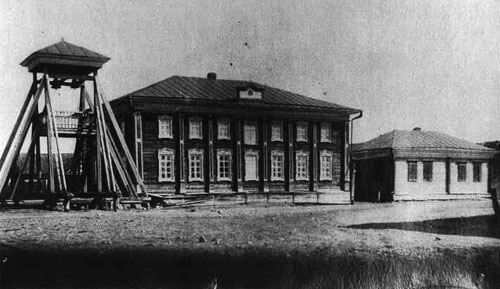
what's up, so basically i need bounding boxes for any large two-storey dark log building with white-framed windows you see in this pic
[111,73,361,200]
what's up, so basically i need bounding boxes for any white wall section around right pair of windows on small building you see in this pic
[450,162,488,194]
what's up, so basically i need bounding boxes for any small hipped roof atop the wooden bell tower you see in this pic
[21,40,110,71]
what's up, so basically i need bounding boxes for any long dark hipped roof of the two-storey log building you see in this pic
[115,76,360,114]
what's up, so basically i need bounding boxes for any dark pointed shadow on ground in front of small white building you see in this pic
[346,215,500,239]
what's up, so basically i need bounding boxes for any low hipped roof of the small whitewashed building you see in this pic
[353,130,494,157]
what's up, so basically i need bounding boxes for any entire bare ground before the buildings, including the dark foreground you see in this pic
[0,200,500,288]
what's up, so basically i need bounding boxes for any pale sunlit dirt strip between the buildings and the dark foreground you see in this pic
[0,200,500,288]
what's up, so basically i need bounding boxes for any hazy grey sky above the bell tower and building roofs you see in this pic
[0,0,500,149]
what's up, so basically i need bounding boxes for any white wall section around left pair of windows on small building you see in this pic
[394,160,446,198]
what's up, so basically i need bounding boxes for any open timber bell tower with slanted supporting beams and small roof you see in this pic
[0,39,147,210]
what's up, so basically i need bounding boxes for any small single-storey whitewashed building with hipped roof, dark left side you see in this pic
[352,128,495,201]
